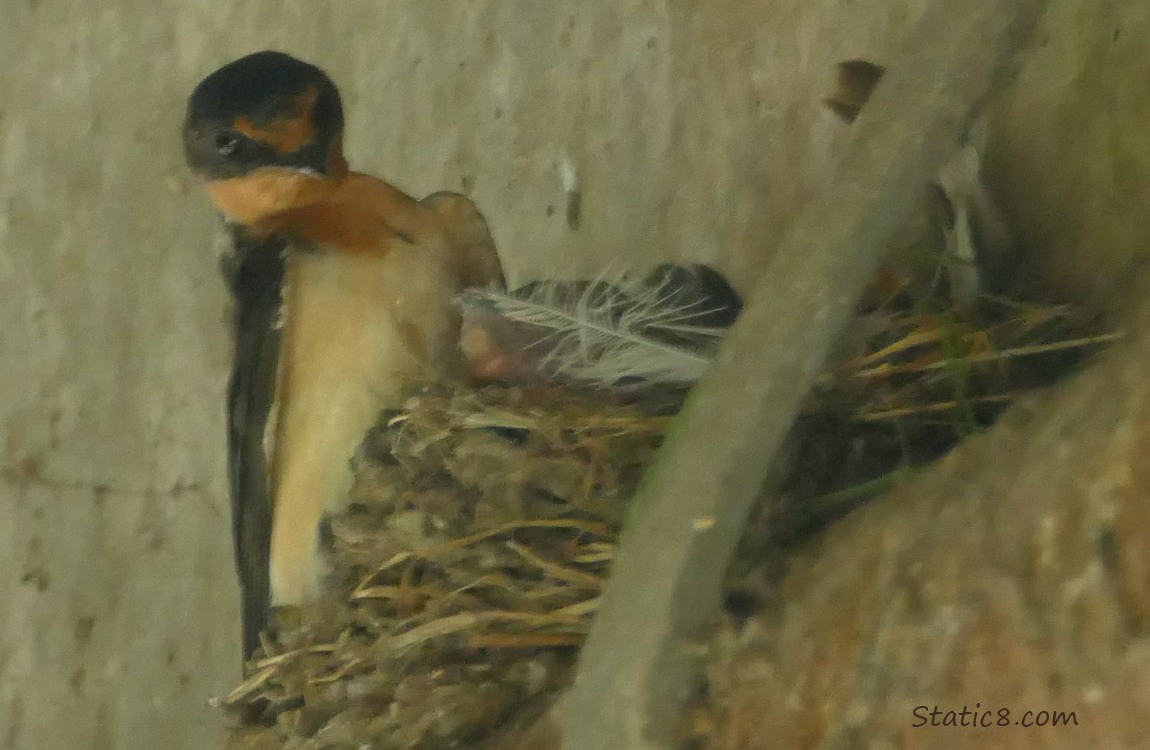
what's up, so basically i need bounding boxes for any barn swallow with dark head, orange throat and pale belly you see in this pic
[183,52,503,656]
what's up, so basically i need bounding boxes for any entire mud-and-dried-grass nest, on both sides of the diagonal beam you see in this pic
[220,291,1116,750]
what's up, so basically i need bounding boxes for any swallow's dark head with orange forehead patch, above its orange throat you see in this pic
[184,51,346,181]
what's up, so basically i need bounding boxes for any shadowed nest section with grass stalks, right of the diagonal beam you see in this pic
[736,288,1120,569]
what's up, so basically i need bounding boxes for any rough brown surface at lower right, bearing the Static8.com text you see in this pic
[707,299,1150,750]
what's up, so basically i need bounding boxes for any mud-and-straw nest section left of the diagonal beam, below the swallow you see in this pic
[221,388,669,748]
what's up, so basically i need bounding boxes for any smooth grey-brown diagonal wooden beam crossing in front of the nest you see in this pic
[564,0,1045,750]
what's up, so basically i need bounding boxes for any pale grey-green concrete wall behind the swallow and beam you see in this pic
[0,0,1150,750]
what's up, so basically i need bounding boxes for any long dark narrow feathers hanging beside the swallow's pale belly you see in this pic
[221,228,285,659]
